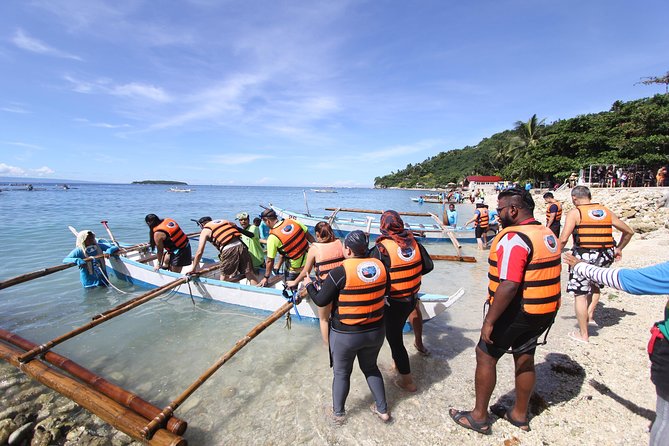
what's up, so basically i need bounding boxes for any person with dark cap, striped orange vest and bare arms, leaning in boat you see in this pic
[192,217,258,285]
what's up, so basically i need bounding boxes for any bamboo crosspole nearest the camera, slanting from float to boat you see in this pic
[142,296,302,440]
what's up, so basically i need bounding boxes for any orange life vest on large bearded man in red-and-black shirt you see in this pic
[488,222,562,314]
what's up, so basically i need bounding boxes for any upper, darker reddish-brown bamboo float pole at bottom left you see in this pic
[0,329,188,435]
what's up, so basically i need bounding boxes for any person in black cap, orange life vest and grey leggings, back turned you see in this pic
[301,230,390,424]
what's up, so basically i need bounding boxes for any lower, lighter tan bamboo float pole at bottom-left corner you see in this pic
[0,343,188,446]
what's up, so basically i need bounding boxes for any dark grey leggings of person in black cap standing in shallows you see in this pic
[330,326,388,415]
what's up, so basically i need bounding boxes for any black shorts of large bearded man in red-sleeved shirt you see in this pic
[478,305,556,358]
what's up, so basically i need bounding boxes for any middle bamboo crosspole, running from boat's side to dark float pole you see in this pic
[19,263,222,363]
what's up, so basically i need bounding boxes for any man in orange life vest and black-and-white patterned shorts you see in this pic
[560,186,634,342]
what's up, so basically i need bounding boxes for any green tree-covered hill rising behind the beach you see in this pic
[374,94,669,188]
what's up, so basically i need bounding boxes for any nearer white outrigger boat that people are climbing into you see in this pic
[105,242,464,321]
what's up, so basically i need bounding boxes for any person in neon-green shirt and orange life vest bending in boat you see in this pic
[258,209,315,286]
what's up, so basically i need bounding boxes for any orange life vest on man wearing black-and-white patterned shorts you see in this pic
[574,203,616,249]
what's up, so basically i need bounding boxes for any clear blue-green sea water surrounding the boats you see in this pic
[0,184,484,444]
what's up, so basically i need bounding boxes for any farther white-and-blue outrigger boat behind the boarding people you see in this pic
[270,204,476,243]
